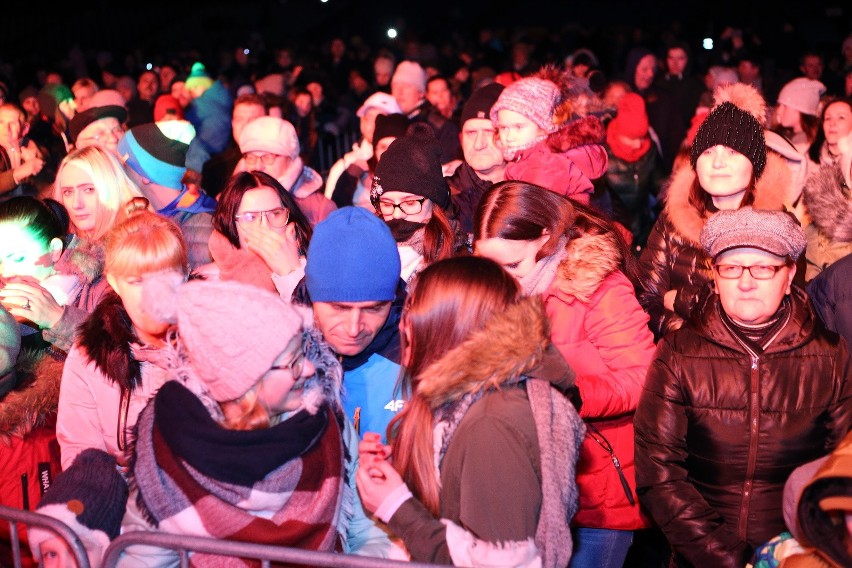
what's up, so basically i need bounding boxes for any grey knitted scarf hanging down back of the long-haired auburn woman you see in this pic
[433,379,586,568]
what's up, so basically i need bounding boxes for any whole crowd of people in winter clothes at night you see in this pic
[0,20,852,568]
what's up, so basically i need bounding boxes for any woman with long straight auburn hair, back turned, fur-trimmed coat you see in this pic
[357,257,585,568]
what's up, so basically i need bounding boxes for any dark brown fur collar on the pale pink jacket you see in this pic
[77,291,142,392]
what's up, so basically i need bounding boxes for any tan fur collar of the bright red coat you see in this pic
[551,233,622,302]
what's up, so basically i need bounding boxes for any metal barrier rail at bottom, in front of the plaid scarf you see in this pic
[102,531,435,568]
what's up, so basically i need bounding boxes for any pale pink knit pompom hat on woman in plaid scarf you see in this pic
[143,275,304,402]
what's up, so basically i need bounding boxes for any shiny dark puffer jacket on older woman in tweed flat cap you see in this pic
[634,286,852,568]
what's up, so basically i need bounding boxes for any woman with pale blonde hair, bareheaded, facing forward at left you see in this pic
[0,147,147,352]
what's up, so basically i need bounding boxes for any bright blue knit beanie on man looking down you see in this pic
[305,206,401,302]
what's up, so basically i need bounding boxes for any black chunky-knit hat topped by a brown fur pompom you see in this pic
[689,102,766,179]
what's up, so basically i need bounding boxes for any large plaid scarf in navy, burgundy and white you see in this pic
[133,381,343,567]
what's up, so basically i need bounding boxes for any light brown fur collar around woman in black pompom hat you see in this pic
[665,153,793,247]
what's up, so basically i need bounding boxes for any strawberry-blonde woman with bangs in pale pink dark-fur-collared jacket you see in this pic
[56,202,189,467]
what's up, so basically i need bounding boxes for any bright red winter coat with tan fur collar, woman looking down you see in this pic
[543,230,654,530]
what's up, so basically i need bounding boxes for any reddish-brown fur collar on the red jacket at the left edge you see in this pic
[0,350,63,444]
